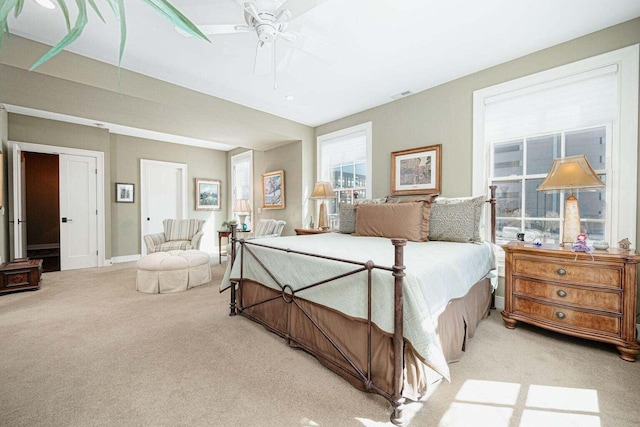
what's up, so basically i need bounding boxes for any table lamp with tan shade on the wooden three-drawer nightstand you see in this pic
[538,154,605,246]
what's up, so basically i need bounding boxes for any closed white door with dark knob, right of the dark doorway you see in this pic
[59,154,98,270]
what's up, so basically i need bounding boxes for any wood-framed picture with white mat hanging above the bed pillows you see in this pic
[391,144,442,194]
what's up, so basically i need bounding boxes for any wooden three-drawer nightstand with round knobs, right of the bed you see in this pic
[502,242,640,362]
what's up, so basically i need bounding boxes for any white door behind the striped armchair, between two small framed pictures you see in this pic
[140,159,187,255]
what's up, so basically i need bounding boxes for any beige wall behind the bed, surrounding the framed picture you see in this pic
[316,18,640,300]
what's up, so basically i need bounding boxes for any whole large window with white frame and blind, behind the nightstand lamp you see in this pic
[473,45,639,252]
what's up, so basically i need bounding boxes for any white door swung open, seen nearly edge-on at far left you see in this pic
[9,144,27,260]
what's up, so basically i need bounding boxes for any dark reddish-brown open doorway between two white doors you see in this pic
[21,151,60,271]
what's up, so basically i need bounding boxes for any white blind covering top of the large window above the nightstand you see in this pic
[485,64,619,141]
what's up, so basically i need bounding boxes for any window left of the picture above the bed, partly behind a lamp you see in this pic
[317,122,371,229]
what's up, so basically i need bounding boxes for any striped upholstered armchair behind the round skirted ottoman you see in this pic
[144,219,205,253]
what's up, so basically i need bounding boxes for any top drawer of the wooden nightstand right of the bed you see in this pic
[513,258,623,288]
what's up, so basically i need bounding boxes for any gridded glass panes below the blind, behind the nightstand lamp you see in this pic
[489,126,610,243]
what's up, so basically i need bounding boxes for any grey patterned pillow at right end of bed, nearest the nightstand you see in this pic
[429,196,485,242]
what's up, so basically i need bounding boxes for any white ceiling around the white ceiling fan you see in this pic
[9,0,640,140]
